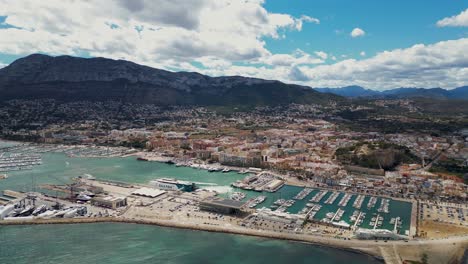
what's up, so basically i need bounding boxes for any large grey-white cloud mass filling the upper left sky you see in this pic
[0,0,319,67]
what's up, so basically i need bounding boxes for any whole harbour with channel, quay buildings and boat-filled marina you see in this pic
[0,140,450,264]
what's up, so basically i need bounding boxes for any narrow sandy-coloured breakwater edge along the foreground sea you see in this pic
[0,217,384,263]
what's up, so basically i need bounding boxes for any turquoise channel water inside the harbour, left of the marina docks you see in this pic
[0,153,245,192]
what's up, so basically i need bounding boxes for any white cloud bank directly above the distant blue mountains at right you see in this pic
[294,38,468,89]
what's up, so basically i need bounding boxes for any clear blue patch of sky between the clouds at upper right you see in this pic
[265,0,468,58]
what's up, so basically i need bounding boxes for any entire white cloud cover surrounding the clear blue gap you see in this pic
[0,0,468,89]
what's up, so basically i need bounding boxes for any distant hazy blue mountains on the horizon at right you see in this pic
[315,86,468,100]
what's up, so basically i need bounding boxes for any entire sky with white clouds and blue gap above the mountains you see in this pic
[0,0,468,90]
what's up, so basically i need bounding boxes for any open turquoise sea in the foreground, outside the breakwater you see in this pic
[0,224,379,264]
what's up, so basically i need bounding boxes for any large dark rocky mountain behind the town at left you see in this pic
[0,54,336,105]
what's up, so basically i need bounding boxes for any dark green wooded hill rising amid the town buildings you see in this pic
[335,142,419,170]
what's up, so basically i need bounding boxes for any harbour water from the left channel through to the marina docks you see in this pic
[0,142,411,234]
